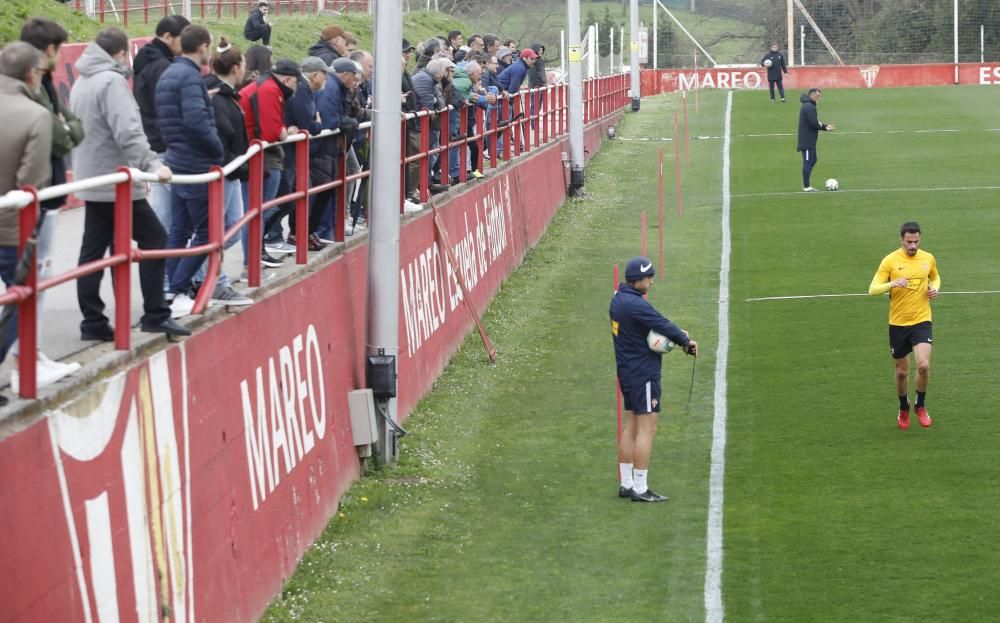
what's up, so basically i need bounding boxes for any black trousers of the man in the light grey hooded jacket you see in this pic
[76,199,170,332]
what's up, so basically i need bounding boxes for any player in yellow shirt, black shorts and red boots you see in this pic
[868,221,941,430]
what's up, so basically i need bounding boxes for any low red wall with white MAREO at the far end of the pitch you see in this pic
[640,63,1000,96]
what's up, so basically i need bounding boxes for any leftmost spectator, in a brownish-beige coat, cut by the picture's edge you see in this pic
[0,42,66,406]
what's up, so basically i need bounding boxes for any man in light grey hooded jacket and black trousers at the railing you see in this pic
[70,28,191,341]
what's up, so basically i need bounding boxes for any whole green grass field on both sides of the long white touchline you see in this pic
[264,88,1000,621]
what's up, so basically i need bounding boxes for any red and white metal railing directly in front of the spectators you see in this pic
[0,74,629,398]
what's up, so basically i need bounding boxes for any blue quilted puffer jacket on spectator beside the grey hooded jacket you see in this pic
[156,56,225,173]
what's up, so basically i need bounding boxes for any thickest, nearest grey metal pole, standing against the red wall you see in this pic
[368,0,403,463]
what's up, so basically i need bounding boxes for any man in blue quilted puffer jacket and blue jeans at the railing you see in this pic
[156,25,225,317]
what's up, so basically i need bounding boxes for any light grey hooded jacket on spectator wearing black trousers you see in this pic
[69,43,163,202]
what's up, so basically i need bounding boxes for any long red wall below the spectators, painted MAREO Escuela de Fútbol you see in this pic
[0,113,613,623]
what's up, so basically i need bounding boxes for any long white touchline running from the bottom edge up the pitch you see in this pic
[705,91,733,623]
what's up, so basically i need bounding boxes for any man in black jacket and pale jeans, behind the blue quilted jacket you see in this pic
[132,15,191,249]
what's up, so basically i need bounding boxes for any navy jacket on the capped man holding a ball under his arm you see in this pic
[608,283,690,390]
